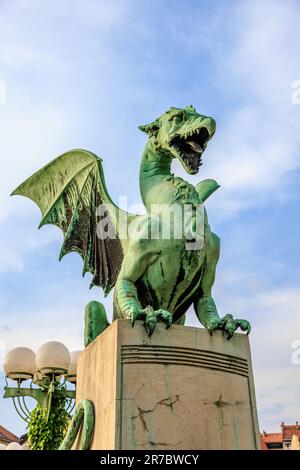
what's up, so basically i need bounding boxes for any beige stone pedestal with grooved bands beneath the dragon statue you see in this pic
[76,320,260,450]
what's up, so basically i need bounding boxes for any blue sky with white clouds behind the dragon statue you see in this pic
[0,0,300,434]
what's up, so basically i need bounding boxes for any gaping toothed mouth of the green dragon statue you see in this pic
[171,127,209,174]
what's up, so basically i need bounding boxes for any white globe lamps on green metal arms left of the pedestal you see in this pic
[4,341,79,422]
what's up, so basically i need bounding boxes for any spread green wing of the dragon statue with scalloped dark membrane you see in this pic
[13,150,123,294]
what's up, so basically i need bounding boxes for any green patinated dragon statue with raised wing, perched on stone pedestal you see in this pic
[13,106,250,345]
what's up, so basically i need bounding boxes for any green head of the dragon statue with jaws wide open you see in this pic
[139,106,216,175]
